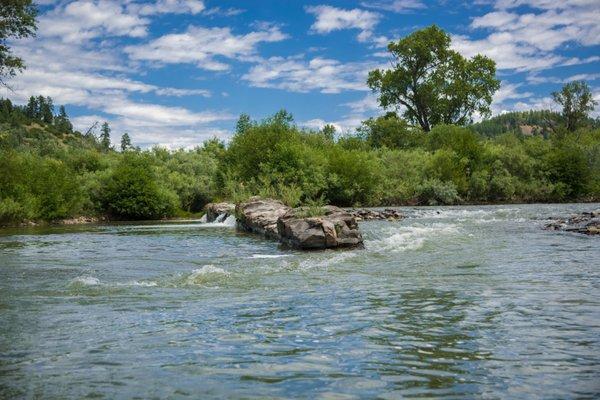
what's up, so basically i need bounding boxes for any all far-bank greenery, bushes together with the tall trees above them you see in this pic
[0,25,600,226]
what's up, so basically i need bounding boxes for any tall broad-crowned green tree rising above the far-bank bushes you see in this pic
[367,25,500,132]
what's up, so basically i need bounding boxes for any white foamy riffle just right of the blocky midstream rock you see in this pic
[367,223,460,252]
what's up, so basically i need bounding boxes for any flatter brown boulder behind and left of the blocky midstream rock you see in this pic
[235,197,291,240]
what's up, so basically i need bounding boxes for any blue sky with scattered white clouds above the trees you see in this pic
[0,0,600,148]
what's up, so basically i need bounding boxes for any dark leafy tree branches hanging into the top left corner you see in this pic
[0,0,37,86]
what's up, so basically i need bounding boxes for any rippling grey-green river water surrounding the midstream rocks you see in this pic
[0,204,600,399]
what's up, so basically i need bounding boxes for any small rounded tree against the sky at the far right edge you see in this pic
[552,81,598,132]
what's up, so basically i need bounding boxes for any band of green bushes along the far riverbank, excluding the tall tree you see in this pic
[0,100,600,226]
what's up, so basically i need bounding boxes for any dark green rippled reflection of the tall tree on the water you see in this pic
[358,289,489,397]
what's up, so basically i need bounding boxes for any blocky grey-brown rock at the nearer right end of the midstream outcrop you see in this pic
[277,206,363,250]
